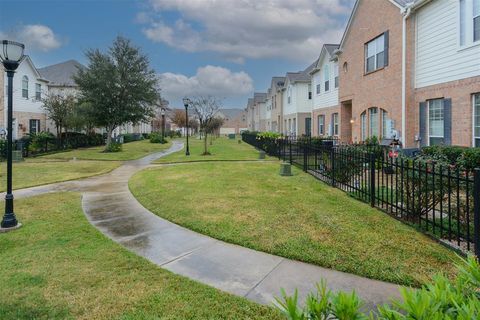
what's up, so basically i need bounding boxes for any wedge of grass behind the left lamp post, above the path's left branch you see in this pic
[0,158,121,191]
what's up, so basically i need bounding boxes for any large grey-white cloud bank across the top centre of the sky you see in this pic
[143,0,354,63]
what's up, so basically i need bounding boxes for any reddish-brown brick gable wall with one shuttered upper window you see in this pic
[339,0,403,141]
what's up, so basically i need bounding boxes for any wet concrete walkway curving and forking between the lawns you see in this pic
[10,142,399,309]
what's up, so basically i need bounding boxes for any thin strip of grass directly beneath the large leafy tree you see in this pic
[40,140,172,161]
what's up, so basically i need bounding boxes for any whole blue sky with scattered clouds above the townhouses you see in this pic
[0,0,353,108]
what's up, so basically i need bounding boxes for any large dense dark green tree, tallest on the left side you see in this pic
[74,37,160,150]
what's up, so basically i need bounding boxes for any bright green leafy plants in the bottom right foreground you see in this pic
[276,256,480,320]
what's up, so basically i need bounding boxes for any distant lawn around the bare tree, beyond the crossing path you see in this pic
[155,137,268,163]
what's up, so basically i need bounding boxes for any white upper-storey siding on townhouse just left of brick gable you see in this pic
[312,54,338,109]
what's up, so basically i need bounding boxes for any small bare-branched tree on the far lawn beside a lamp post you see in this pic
[192,96,221,155]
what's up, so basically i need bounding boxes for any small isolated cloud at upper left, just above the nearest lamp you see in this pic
[0,24,62,52]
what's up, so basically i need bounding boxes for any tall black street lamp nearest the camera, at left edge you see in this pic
[0,40,25,229]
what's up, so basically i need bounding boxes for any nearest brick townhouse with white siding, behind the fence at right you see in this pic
[337,0,480,147]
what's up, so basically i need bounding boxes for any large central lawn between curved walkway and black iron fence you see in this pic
[129,162,456,286]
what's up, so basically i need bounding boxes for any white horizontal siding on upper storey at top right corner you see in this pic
[415,0,480,88]
